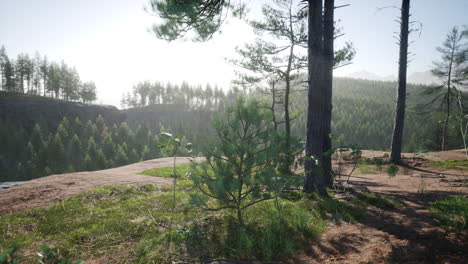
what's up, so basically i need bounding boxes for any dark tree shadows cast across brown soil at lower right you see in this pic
[296,172,468,264]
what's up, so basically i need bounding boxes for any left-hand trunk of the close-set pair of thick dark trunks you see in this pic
[304,0,326,195]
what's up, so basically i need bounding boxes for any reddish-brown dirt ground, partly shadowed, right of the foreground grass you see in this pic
[302,150,468,264]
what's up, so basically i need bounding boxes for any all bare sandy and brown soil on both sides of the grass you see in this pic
[0,150,468,263]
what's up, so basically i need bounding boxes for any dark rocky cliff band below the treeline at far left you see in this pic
[0,97,126,131]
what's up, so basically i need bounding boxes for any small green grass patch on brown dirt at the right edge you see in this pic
[430,196,468,229]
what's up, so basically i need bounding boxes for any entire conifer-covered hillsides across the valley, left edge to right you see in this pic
[0,78,463,182]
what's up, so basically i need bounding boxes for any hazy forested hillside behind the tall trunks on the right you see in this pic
[293,78,463,152]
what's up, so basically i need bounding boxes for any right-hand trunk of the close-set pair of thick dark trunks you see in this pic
[323,0,335,186]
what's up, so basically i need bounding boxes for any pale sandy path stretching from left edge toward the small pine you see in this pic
[0,157,202,215]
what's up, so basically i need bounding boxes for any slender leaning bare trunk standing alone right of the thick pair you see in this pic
[390,0,410,163]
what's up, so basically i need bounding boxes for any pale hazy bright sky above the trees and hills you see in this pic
[0,0,468,105]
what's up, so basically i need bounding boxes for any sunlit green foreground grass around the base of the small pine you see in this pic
[0,180,336,263]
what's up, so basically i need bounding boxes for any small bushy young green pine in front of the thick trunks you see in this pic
[191,97,292,228]
